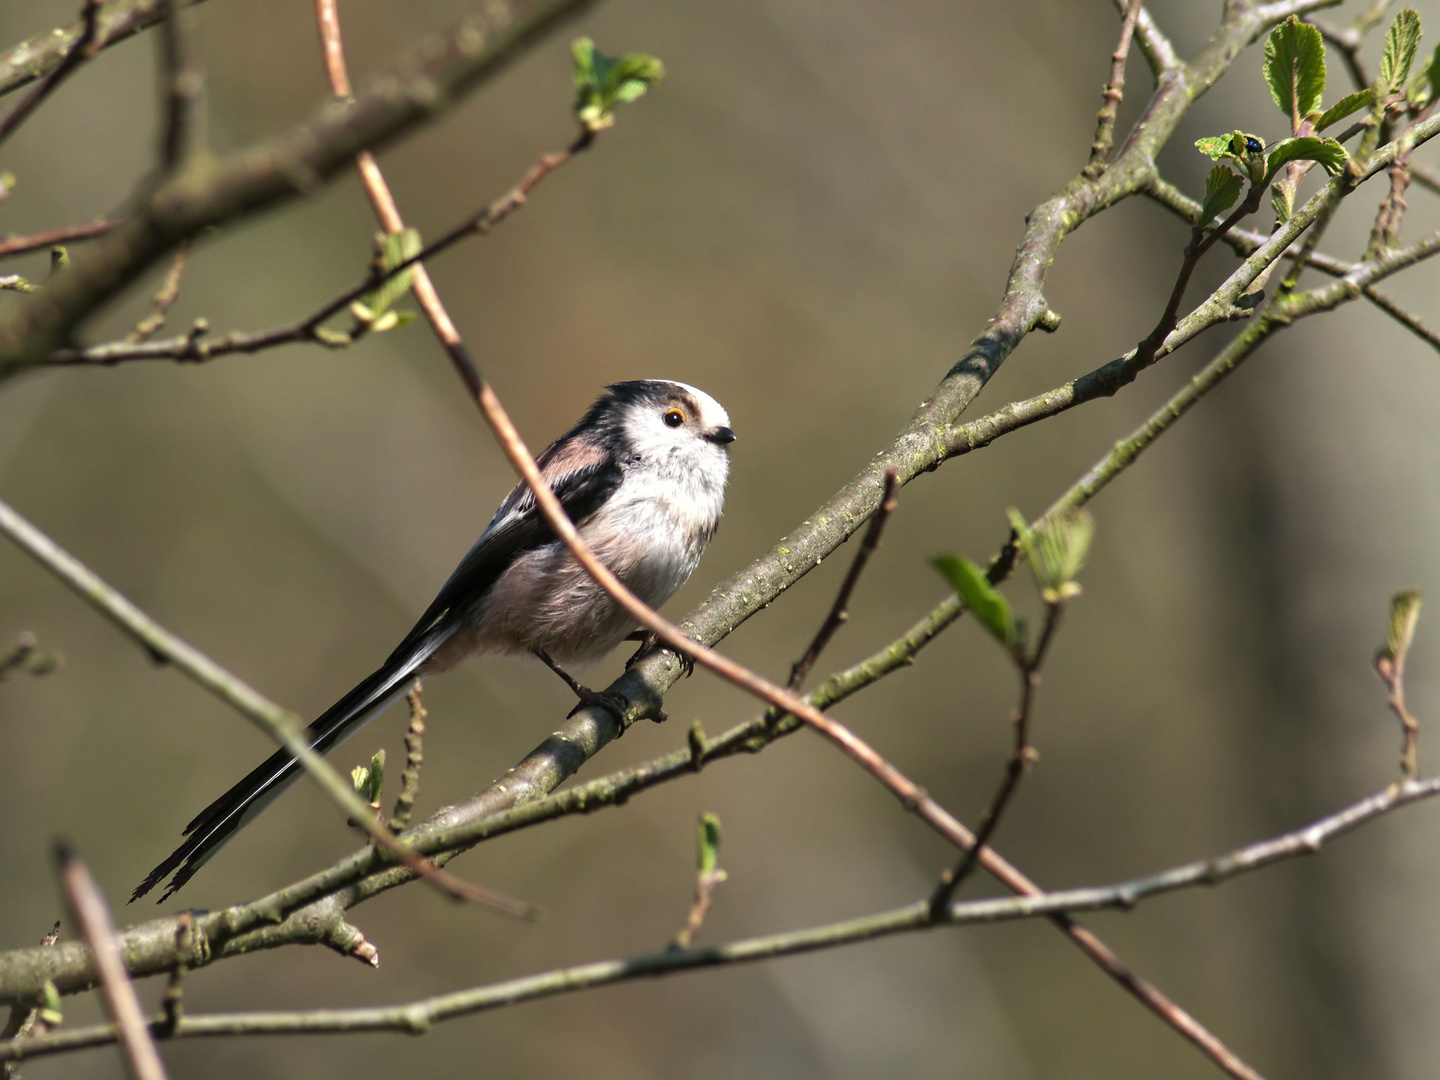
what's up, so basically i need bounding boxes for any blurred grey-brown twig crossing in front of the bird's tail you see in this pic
[0,501,536,917]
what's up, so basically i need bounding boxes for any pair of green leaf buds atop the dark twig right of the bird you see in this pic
[933,510,1094,662]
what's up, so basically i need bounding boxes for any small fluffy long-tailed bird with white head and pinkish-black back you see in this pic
[130,379,734,903]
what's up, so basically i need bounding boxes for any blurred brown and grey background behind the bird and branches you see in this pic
[0,0,1440,1080]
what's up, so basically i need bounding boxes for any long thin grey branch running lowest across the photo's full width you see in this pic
[11,776,1440,1061]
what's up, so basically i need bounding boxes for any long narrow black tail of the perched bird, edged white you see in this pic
[130,632,449,903]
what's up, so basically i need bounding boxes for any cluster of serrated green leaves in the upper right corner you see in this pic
[1195,7,1440,229]
